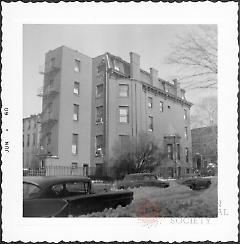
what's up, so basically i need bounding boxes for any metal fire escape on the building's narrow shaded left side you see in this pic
[36,59,60,159]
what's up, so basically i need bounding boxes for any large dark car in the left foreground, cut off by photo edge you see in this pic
[23,176,133,217]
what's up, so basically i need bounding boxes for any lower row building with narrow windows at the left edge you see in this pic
[23,114,41,168]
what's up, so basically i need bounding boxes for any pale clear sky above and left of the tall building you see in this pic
[23,24,216,117]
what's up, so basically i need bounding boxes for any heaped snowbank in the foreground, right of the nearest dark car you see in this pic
[81,177,218,217]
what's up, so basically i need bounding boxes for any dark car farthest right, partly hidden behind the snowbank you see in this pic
[178,177,211,190]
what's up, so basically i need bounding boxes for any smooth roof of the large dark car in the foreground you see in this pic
[23,176,91,188]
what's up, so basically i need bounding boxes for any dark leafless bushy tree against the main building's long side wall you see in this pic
[112,132,165,177]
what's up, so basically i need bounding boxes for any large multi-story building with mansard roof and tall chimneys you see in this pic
[35,46,192,177]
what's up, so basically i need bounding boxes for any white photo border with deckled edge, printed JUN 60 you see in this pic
[1,2,239,242]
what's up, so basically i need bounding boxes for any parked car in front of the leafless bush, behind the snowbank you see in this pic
[116,173,169,189]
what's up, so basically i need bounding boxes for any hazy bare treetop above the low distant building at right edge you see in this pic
[191,96,218,128]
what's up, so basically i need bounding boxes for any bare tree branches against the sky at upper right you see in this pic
[166,25,218,89]
